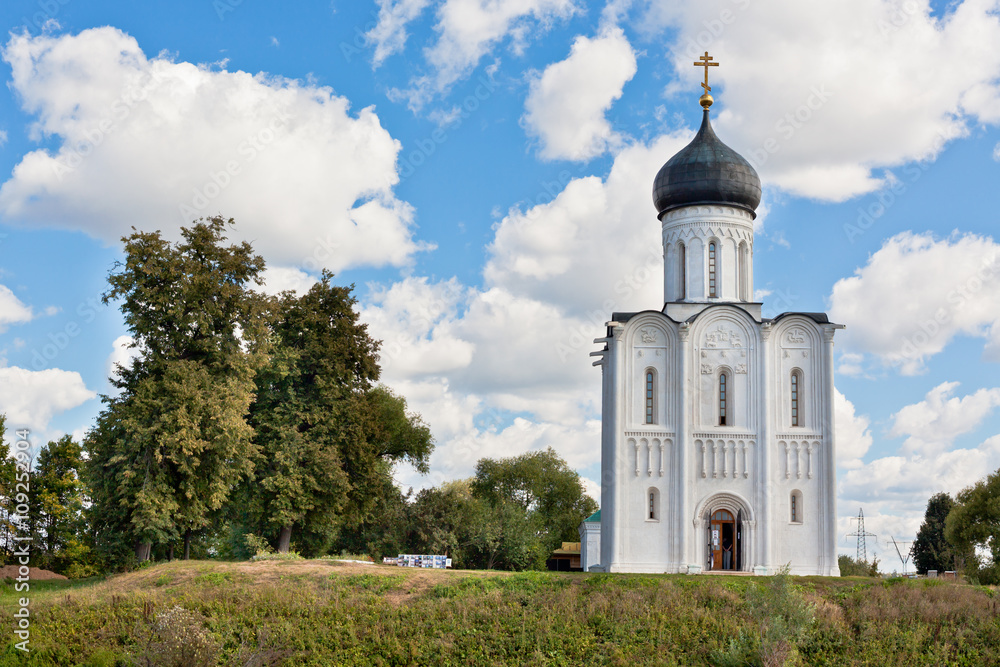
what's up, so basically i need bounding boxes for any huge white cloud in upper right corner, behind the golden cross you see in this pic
[642,0,1000,200]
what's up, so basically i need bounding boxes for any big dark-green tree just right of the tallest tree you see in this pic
[243,272,432,553]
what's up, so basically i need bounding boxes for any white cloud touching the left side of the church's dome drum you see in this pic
[483,131,691,318]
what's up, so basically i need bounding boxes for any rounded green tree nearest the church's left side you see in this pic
[471,449,597,569]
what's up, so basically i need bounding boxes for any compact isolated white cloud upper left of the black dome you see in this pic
[522,28,636,160]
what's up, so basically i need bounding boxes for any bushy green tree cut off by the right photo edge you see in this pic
[944,470,1000,584]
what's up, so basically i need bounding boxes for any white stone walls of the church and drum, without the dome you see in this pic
[581,207,839,575]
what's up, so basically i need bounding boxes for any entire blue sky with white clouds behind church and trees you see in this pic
[0,0,1000,564]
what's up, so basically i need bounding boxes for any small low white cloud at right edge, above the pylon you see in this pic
[889,382,1000,457]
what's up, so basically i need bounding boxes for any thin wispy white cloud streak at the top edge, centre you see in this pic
[387,0,577,109]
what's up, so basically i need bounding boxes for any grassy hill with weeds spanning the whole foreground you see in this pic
[0,561,1000,666]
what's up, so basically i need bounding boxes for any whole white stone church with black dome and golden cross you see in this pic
[580,53,843,576]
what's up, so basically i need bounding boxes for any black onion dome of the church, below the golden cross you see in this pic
[653,108,760,220]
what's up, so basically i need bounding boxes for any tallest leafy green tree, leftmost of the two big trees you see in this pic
[85,217,266,561]
